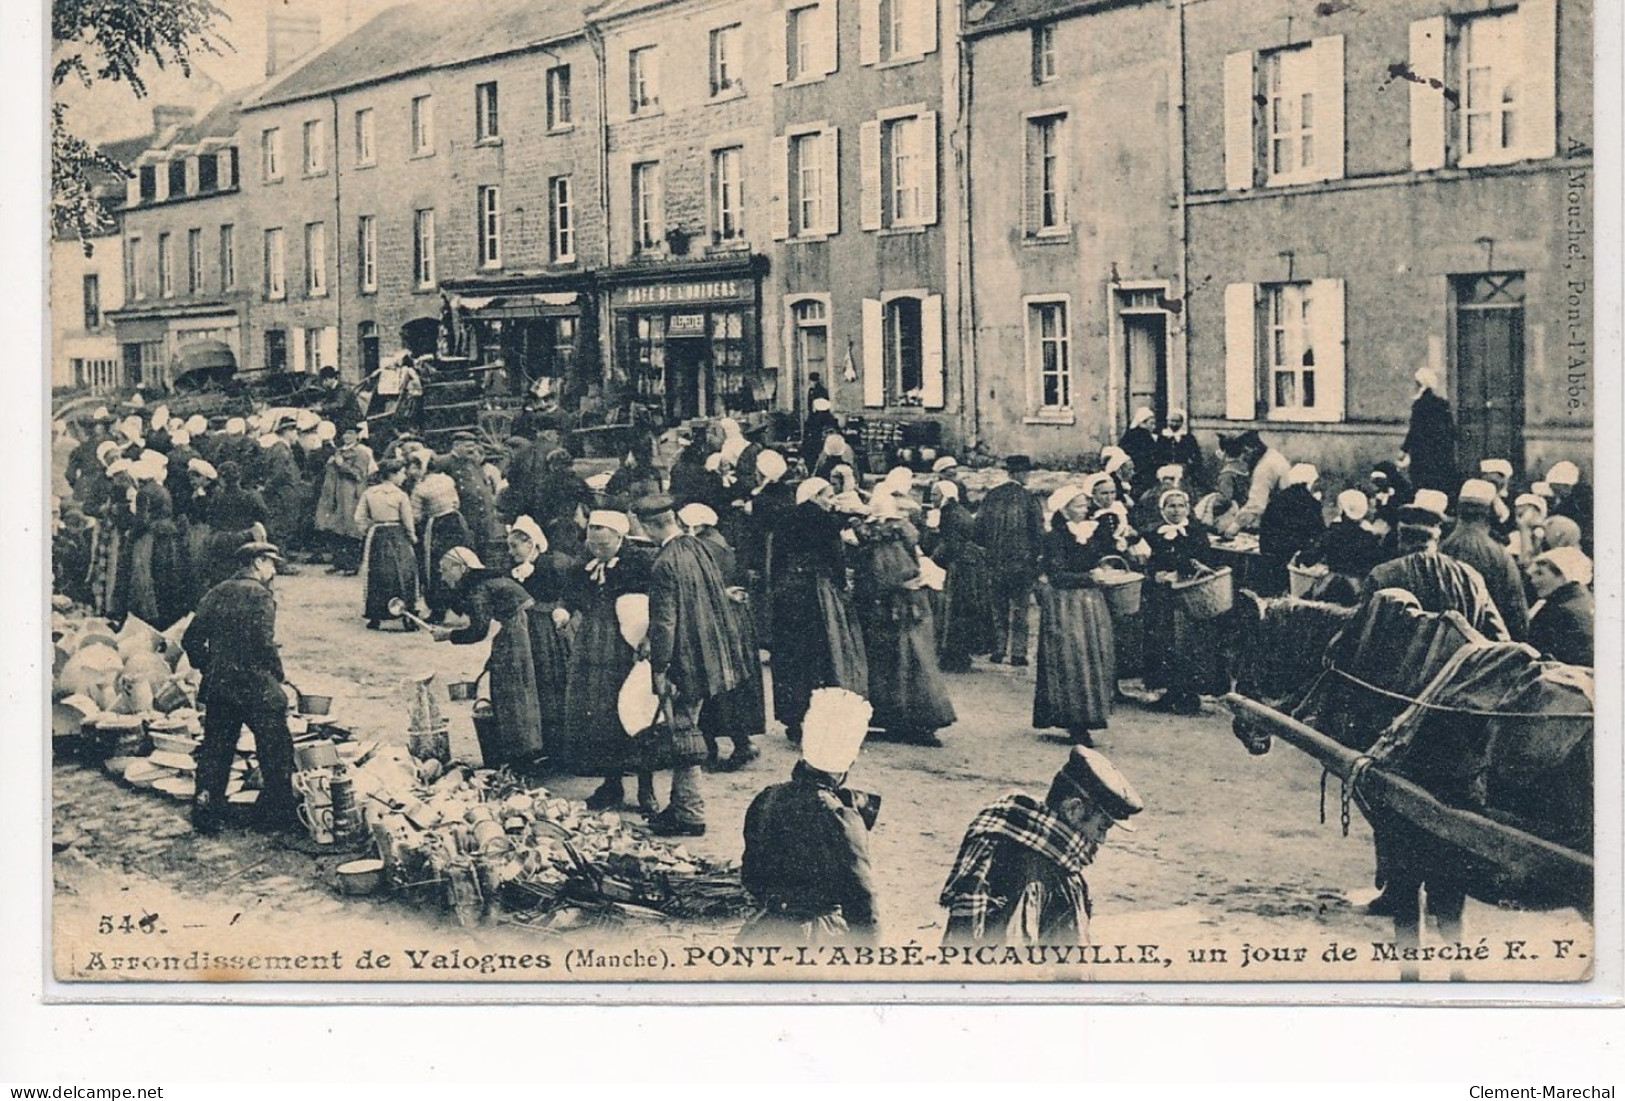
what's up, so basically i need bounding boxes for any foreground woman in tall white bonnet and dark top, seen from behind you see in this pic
[739,689,881,943]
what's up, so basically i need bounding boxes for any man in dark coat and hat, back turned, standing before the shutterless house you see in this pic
[977,455,1043,666]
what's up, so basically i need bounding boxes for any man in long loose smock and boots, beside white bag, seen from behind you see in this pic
[637,497,751,836]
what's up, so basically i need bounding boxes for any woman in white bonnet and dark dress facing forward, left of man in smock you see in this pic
[551,508,660,814]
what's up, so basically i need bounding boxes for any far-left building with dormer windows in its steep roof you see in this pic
[106,96,252,388]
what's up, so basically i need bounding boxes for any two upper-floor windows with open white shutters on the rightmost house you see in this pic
[1224,0,1557,190]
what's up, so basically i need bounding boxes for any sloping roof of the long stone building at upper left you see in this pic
[247,0,583,109]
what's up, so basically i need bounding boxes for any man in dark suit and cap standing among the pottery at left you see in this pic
[180,542,299,833]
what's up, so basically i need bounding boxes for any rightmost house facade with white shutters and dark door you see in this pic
[1181,0,1593,476]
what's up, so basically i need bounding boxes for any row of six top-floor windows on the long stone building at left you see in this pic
[260,65,575,184]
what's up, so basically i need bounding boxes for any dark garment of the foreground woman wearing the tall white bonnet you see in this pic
[739,762,878,945]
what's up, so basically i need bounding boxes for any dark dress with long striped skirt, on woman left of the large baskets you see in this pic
[1032,513,1116,732]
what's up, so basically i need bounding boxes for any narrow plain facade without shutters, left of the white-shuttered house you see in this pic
[962,0,1188,460]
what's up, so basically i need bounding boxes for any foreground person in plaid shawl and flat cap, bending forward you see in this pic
[941,745,1146,947]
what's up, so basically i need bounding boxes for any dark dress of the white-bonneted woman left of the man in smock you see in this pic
[553,542,653,776]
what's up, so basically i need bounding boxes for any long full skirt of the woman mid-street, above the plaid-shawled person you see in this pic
[863,589,959,734]
